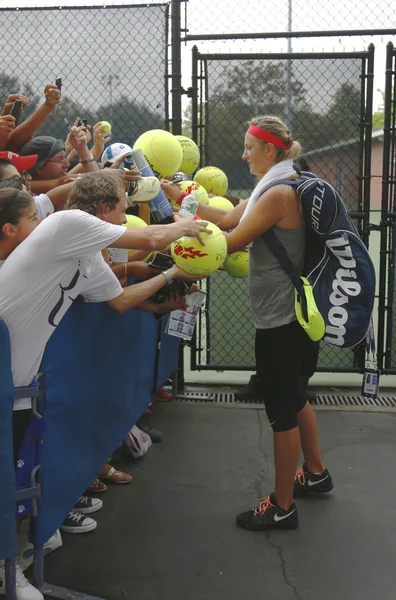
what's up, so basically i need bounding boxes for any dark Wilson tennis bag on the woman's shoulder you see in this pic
[264,171,375,348]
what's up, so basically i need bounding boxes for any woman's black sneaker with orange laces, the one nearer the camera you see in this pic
[236,494,298,531]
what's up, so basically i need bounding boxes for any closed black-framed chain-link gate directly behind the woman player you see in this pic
[191,45,374,372]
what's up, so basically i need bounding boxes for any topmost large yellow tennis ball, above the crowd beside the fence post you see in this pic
[133,129,183,179]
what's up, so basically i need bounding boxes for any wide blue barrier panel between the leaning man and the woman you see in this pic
[35,298,178,544]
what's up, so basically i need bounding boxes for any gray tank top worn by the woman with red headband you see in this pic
[249,225,305,329]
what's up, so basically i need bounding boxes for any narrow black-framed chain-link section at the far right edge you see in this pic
[378,43,396,373]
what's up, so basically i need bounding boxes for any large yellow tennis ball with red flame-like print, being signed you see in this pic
[171,223,227,275]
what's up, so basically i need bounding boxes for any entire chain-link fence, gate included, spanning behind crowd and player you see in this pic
[0,0,396,371]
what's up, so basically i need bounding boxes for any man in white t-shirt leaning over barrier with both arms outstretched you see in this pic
[0,171,209,410]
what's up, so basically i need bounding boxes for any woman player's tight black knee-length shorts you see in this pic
[256,321,307,432]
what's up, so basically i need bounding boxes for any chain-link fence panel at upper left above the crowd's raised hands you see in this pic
[0,4,169,144]
